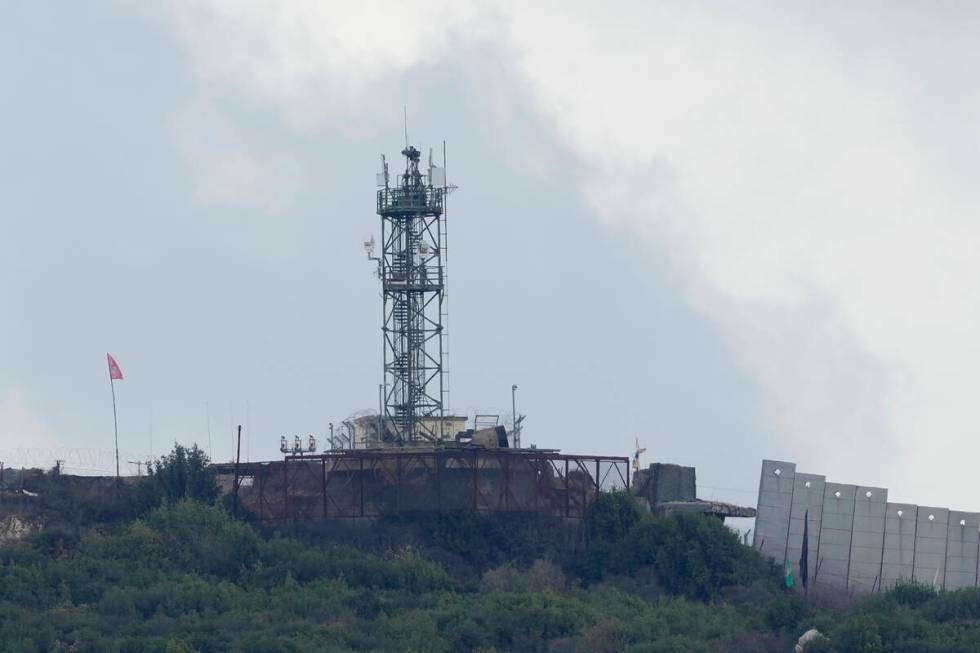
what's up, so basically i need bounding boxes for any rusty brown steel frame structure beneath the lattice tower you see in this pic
[215,447,630,520]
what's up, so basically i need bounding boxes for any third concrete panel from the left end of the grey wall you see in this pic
[814,483,857,589]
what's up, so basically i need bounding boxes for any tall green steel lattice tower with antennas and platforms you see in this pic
[368,146,451,445]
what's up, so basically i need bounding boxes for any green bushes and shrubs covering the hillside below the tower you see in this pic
[0,450,980,653]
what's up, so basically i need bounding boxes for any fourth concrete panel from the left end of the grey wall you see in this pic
[847,486,888,593]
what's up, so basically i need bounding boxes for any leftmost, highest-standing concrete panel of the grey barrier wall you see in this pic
[752,460,796,564]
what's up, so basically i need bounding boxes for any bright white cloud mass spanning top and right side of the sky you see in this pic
[155,0,980,507]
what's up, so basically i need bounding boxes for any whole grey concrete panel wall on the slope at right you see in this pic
[754,460,980,593]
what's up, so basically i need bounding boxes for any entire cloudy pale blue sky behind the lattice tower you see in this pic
[0,0,980,510]
